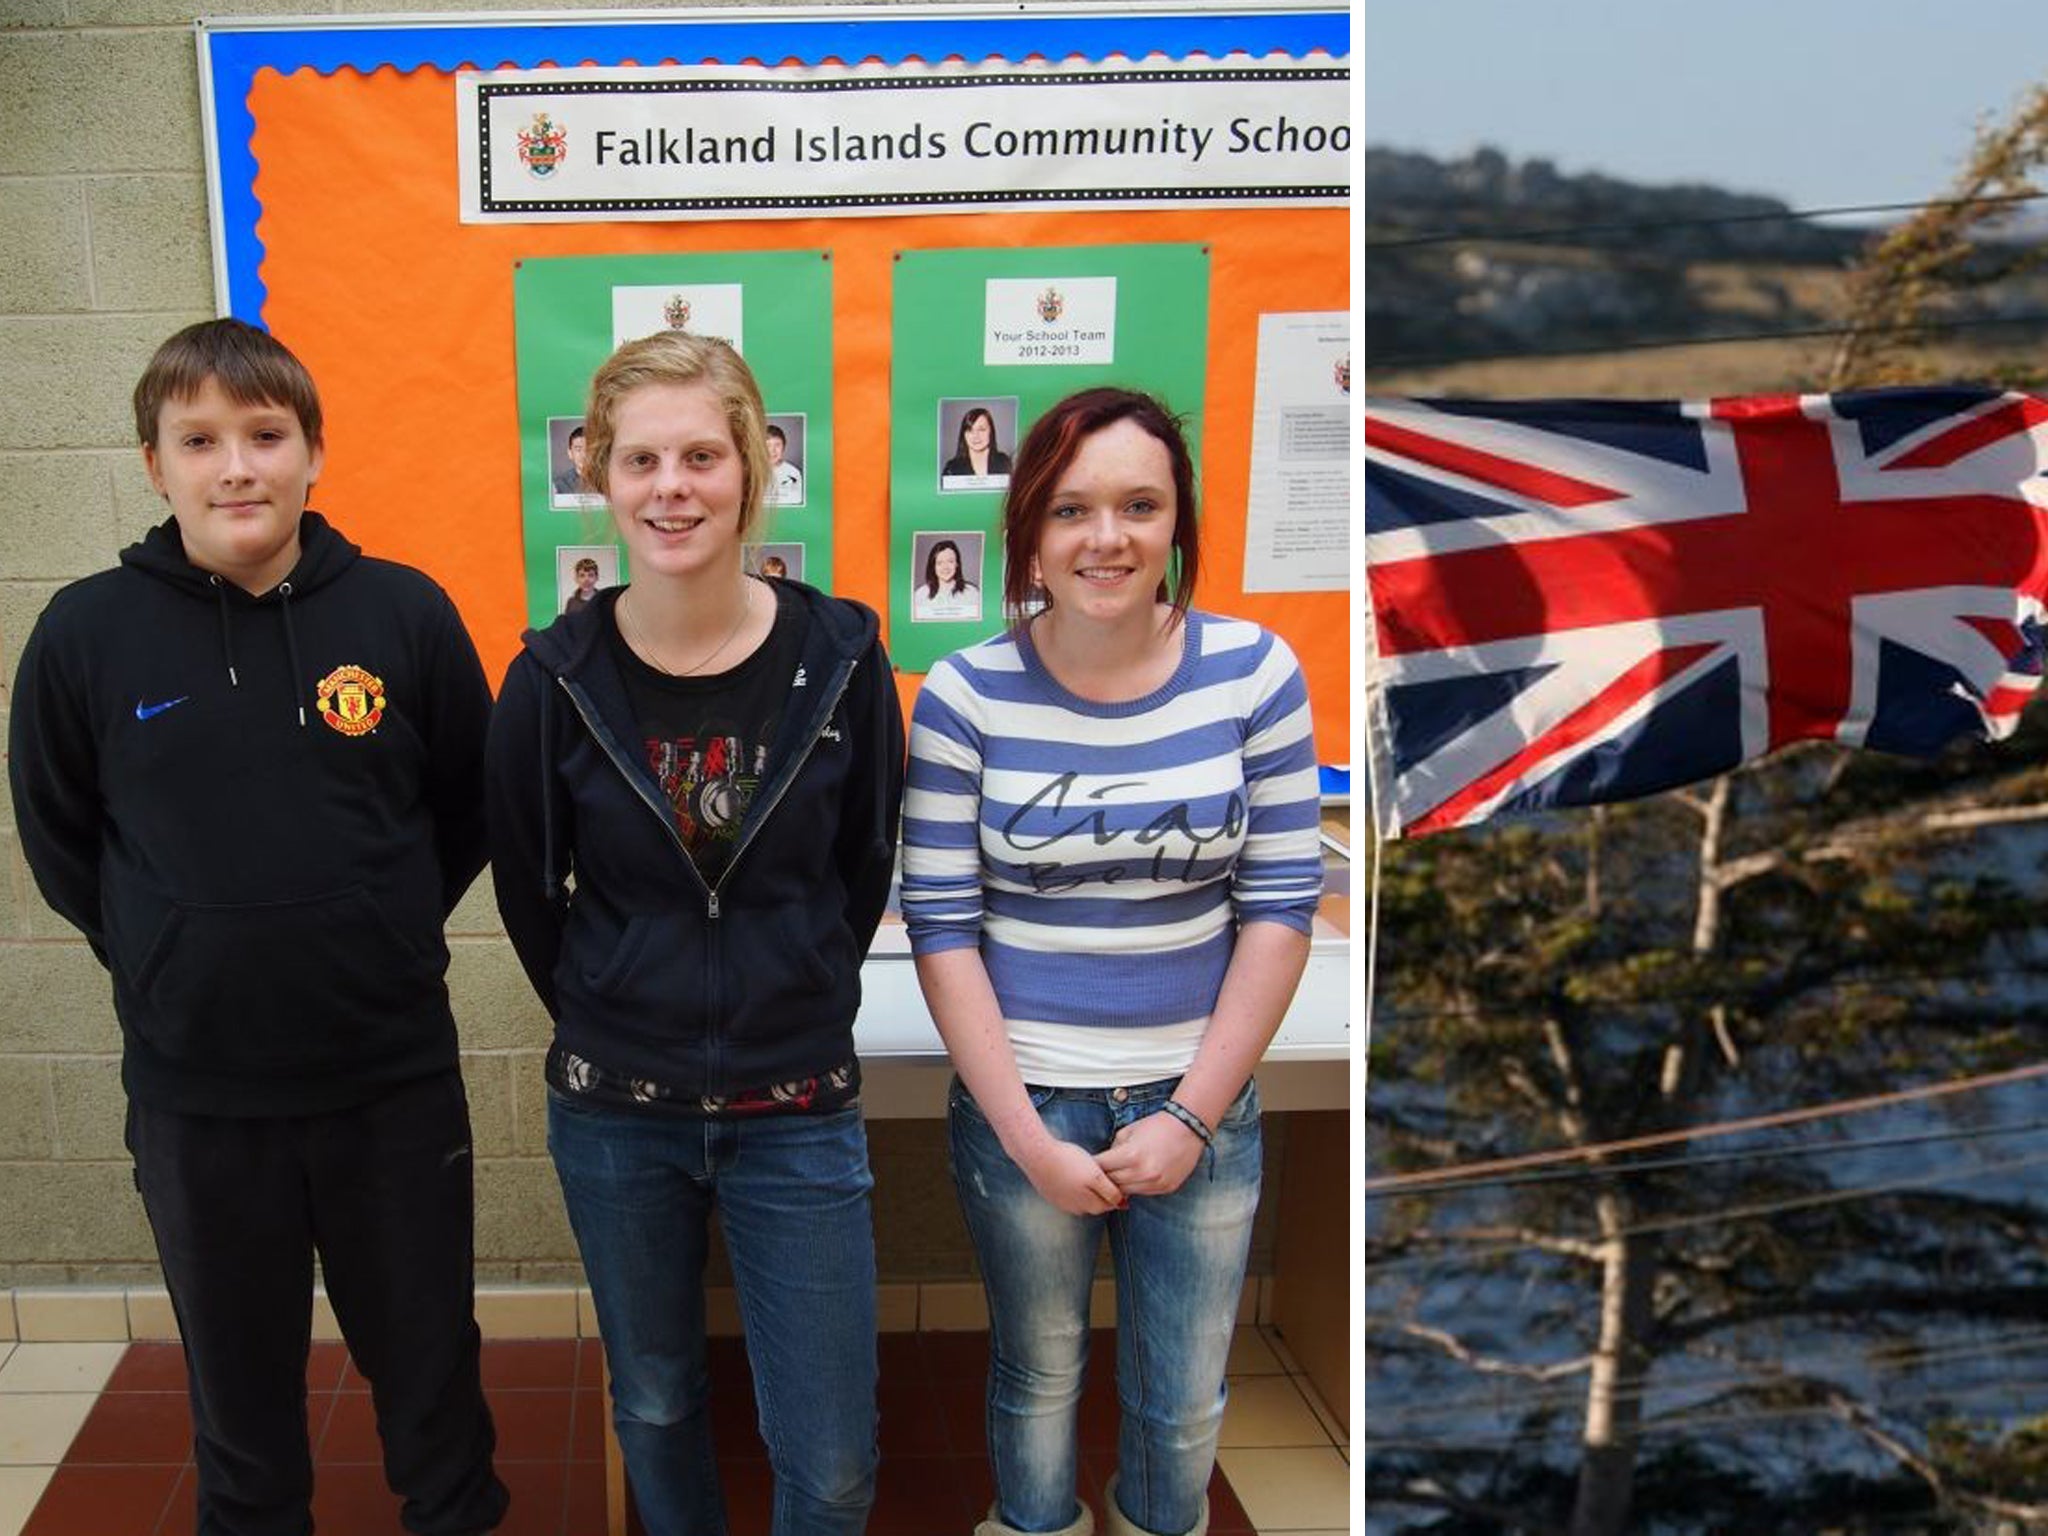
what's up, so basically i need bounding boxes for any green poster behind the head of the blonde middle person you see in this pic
[512,250,831,625]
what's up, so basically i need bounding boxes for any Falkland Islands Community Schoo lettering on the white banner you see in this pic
[592,115,1352,166]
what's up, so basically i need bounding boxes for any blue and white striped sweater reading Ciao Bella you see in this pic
[903,612,1323,1085]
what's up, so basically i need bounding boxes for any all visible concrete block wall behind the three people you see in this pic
[0,0,1284,1290]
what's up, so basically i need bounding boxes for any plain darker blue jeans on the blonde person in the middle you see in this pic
[547,1094,877,1536]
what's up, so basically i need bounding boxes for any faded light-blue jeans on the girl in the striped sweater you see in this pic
[948,1077,1260,1536]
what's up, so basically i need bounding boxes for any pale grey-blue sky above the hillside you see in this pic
[1362,0,2048,209]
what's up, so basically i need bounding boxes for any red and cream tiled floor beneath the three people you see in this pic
[0,1327,1348,1536]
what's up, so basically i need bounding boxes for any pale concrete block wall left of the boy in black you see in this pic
[0,0,213,1286]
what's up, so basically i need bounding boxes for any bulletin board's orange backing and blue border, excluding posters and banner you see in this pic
[199,6,1352,762]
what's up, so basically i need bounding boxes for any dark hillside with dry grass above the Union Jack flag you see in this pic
[1366,147,2048,395]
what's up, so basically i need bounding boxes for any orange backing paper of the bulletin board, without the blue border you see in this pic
[250,68,1350,762]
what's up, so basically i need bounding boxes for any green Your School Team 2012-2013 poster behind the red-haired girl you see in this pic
[889,246,1208,672]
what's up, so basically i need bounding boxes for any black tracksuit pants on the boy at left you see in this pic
[129,1069,506,1536]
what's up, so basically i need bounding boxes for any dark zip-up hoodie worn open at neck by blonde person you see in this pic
[489,582,903,1096]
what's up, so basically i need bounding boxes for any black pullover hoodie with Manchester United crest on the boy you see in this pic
[8,512,492,1116]
